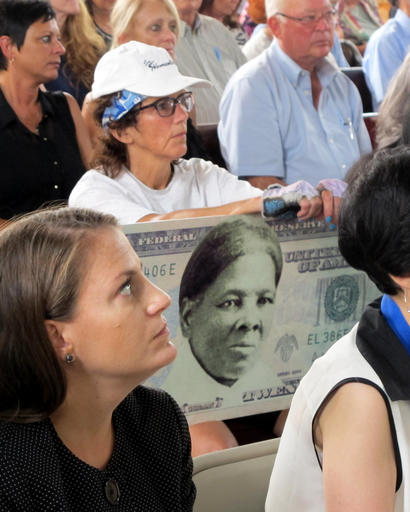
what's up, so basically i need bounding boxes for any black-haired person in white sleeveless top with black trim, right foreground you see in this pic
[265,147,410,512]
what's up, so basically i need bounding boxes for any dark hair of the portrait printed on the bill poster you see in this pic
[179,215,282,307]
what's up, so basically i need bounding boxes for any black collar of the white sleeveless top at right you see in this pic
[356,299,410,401]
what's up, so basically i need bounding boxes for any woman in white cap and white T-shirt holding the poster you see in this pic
[69,41,343,224]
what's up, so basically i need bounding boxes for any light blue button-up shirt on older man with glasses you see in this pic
[218,41,371,185]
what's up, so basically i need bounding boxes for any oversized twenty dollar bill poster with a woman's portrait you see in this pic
[124,215,379,423]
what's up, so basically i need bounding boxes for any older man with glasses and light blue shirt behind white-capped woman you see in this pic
[218,0,371,188]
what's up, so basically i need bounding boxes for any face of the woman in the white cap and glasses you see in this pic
[120,91,188,162]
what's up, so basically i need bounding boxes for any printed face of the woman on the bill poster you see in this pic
[185,252,276,385]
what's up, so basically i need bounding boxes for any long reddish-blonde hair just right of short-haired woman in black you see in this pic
[61,0,106,89]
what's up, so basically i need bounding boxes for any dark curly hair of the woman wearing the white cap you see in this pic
[91,92,141,178]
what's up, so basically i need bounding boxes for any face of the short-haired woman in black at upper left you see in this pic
[13,19,65,84]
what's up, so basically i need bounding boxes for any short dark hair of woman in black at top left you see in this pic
[0,0,56,70]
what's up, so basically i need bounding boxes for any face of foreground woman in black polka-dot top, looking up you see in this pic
[55,228,176,386]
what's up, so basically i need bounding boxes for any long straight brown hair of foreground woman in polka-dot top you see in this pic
[0,208,117,422]
